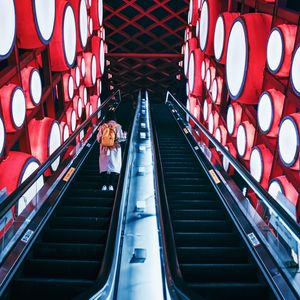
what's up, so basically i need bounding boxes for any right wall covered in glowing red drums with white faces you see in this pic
[181,0,300,221]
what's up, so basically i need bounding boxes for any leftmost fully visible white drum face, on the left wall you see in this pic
[11,88,26,128]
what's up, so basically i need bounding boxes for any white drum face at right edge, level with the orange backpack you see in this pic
[278,117,299,166]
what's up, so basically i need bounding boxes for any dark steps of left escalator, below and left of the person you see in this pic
[5,143,115,299]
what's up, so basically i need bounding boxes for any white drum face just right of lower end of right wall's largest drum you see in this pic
[257,93,274,133]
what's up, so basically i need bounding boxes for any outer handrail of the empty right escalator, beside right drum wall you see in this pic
[165,91,300,239]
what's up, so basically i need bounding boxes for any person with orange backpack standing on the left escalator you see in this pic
[97,109,125,191]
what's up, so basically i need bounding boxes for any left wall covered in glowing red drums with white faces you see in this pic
[0,0,107,217]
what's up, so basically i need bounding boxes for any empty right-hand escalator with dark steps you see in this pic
[152,105,274,300]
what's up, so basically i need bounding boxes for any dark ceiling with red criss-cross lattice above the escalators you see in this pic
[104,0,189,101]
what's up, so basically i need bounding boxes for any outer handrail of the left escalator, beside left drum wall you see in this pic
[0,90,121,220]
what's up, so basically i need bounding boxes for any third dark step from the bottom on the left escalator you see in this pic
[33,243,105,260]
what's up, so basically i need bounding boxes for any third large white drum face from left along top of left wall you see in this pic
[63,4,76,66]
